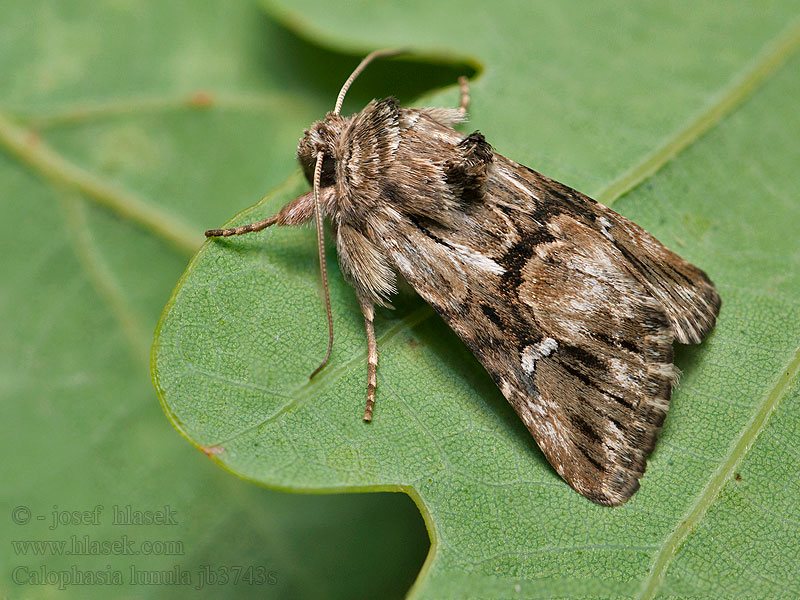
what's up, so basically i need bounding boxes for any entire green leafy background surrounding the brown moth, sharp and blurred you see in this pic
[0,0,800,598]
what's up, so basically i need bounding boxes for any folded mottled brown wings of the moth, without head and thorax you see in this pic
[376,155,719,505]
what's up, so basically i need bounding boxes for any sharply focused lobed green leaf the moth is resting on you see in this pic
[153,0,800,598]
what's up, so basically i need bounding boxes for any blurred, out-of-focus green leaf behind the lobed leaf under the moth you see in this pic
[0,0,455,599]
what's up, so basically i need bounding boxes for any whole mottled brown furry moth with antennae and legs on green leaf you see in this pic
[206,50,721,505]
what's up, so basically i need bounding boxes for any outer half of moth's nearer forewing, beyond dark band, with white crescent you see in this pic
[500,230,676,505]
